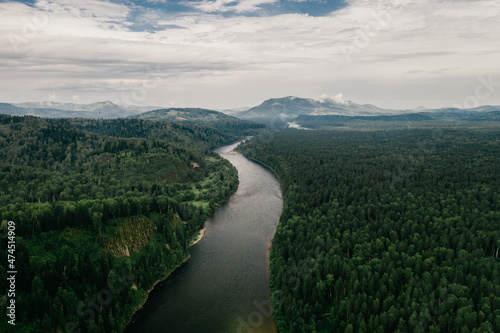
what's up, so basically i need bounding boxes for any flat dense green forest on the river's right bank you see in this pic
[241,127,500,333]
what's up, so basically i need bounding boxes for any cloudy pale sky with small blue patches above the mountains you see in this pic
[0,0,500,109]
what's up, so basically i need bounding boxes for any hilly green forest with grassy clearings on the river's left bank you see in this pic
[0,116,238,332]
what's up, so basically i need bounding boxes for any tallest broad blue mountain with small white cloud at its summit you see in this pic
[235,96,401,120]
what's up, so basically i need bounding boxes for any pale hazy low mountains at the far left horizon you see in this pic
[0,102,160,119]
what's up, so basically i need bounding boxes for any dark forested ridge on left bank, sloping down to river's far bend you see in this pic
[58,118,237,151]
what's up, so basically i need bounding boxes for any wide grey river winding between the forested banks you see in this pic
[125,144,283,333]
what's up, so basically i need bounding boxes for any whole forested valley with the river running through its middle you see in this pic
[0,99,500,333]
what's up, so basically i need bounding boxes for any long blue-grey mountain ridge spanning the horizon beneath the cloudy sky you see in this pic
[0,96,500,125]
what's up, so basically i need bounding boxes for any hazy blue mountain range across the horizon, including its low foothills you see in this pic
[0,96,500,127]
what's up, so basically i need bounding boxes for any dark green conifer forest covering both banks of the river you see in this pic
[0,112,500,333]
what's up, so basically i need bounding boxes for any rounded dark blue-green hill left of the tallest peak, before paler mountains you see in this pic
[130,108,264,136]
